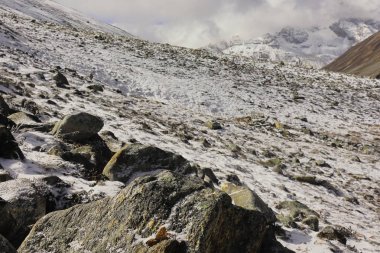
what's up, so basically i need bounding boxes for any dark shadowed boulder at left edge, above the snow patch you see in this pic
[0,125,25,159]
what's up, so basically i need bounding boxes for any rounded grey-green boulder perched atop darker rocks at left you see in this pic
[52,112,104,141]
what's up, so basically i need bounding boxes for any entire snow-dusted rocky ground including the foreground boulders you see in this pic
[0,0,380,252]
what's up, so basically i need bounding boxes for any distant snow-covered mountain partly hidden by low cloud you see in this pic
[207,18,380,67]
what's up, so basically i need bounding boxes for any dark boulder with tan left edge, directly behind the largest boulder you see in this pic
[103,144,196,183]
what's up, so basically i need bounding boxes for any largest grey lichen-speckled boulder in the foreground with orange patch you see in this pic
[18,171,290,253]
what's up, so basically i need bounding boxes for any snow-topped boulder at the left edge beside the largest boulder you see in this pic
[0,179,47,247]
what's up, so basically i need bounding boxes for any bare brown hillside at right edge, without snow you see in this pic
[325,32,380,79]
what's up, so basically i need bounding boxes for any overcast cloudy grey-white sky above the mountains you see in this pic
[56,0,380,47]
